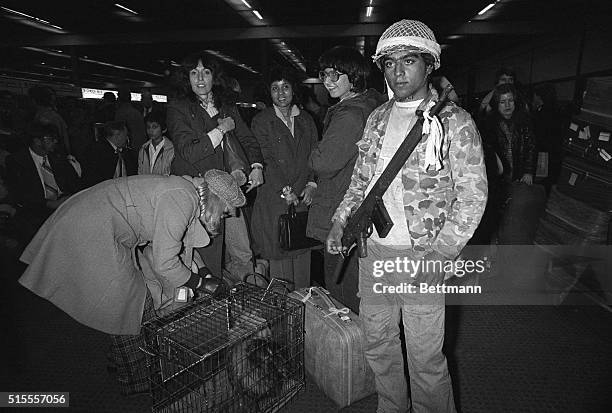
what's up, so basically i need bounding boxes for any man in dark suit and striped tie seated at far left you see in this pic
[6,122,80,242]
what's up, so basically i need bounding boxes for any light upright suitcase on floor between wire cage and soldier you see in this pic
[290,287,376,408]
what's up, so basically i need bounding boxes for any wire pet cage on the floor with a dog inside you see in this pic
[143,284,304,413]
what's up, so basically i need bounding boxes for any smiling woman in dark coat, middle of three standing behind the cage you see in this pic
[251,69,317,288]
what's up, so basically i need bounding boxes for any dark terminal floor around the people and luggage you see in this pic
[0,254,612,413]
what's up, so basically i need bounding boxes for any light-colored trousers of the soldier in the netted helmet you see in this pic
[359,242,456,413]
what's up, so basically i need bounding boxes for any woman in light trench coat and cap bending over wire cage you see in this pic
[19,170,245,394]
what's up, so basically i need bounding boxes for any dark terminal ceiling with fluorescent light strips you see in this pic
[0,0,612,91]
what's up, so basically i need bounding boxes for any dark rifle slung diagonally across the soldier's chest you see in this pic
[334,84,453,284]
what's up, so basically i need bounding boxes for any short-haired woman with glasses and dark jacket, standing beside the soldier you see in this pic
[306,46,385,307]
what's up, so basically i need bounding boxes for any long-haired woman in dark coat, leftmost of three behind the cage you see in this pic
[166,53,264,281]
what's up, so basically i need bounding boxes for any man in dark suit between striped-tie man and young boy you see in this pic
[83,121,138,187]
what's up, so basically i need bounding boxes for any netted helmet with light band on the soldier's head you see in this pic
[372,19,441,69]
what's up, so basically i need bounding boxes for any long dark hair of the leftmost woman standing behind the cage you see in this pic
[170,52,227,109]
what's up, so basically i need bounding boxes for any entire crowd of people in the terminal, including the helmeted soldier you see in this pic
[0,20,562,412]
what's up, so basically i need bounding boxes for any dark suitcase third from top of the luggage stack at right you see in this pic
[557,156,612,211]
